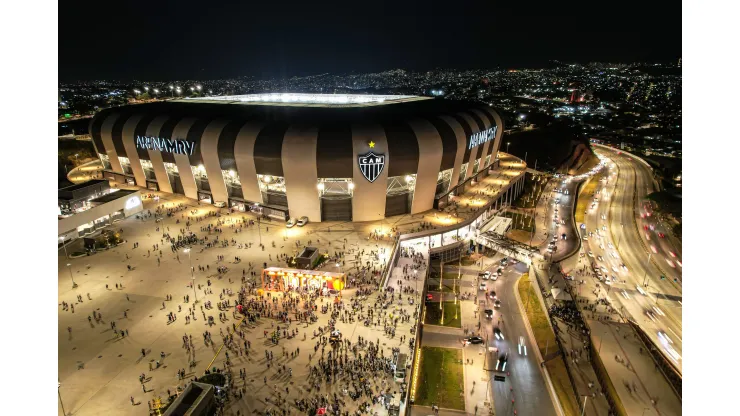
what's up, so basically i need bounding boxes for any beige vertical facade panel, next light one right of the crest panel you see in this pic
[408,119,442,214]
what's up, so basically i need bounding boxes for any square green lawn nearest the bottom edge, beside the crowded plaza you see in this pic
[414,347,465,410]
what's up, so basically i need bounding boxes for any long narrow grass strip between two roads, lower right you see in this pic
[517,273,578,415]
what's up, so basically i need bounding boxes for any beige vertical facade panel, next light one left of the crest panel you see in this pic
[282,126,321,222]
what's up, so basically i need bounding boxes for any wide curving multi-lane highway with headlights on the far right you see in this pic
[579,148,682,371]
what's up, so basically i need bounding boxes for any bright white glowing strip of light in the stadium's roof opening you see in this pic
[189,93,424,105]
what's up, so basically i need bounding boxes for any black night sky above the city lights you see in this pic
[59,0,681,81]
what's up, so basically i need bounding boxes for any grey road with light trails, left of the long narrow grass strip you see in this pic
[480,262,556,416]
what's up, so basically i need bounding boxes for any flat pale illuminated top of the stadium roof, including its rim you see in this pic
[176,93,431,107]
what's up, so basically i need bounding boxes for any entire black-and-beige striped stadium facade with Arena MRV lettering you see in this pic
[90,94,504,222]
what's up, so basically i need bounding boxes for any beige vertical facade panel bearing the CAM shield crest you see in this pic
[352,124,391,222]
